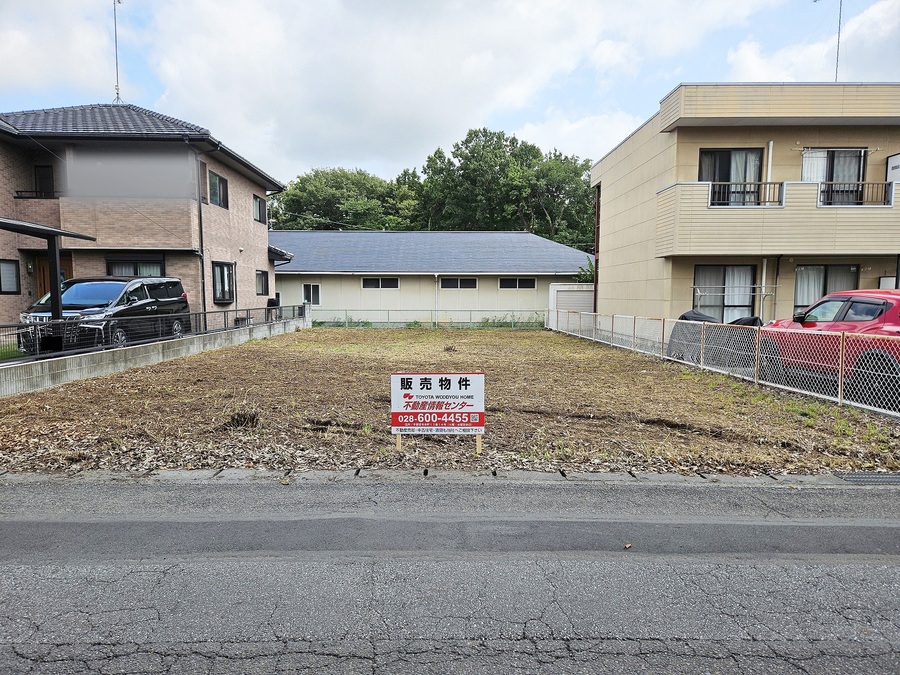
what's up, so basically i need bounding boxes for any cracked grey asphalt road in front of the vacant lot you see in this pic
[0,472,900,674]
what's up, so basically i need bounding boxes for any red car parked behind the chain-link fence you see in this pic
[760,289,900,410]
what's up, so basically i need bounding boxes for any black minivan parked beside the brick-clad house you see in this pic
[19,277,191,354]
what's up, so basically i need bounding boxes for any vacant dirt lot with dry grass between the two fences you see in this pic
[0,328,900,475]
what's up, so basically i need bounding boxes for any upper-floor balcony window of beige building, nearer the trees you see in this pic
[700,148,762,206]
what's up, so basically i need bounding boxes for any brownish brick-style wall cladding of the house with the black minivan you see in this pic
[0,136,275,323]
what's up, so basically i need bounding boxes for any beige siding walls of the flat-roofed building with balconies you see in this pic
[591,84,900,319]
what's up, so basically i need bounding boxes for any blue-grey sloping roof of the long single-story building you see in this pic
[269,230,588,276]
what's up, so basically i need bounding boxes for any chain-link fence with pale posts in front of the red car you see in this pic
[555,310,900,415]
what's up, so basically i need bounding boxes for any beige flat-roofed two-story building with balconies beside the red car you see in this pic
[591,84,900,321]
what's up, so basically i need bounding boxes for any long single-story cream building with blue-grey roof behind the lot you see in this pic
[269,230,590,325]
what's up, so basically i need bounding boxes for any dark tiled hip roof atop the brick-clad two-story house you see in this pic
[0,103,210,137]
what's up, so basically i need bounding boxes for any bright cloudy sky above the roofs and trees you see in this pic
[0,0,900,183]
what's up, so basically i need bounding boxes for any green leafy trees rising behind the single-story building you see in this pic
[269,129,594,251]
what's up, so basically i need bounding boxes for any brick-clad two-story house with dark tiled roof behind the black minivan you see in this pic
[0,104,284,323]
